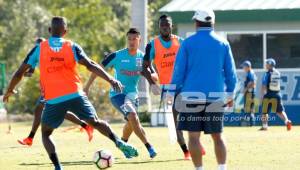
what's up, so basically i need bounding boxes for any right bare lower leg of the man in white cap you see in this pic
[211,133,226,170]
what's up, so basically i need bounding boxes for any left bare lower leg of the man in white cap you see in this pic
[188,131,202,169]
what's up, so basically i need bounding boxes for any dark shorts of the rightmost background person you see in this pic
[262,92,284,114]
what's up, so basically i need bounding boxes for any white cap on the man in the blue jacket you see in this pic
[192,8,216,24]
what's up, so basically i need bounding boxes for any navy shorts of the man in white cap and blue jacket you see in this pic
[177,103,224,134]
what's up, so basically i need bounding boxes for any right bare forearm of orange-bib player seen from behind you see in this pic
[78,58,123,92]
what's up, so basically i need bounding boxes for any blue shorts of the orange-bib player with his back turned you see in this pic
[42,96,98,128]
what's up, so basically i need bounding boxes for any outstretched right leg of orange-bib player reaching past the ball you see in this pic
[68,96,138,158]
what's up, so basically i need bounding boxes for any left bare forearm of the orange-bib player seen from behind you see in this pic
[3,63,31,102]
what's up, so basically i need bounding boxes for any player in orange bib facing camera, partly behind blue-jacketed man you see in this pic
[143,15,205,160]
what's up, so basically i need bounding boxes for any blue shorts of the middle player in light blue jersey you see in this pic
[110,94,139,120]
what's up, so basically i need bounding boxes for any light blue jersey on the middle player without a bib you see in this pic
[102,48,144,99]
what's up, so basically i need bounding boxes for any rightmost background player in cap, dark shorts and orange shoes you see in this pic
[260,58,292,131]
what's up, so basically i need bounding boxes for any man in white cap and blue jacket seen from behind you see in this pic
[172,9,237,170]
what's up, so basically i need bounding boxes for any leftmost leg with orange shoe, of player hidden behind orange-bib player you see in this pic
[18,99,44,146]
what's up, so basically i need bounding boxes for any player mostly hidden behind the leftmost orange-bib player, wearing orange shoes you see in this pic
[18,38,94,146]
